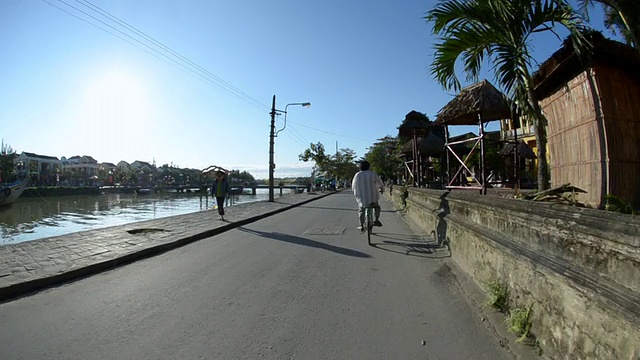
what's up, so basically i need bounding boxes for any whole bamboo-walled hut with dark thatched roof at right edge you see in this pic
[533,33,640,207]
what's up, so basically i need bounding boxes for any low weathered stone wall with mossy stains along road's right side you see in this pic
[387,188,640,359]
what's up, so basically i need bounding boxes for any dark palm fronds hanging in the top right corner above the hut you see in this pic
[579,0,640,50]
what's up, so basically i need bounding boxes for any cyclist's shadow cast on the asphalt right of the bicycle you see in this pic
[371,232,451,259]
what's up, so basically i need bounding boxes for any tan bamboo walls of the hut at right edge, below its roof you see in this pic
[541,65,640,207]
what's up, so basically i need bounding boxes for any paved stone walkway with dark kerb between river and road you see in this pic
[0,192,332,301]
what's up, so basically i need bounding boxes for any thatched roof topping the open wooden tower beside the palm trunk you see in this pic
[435,80,511,125]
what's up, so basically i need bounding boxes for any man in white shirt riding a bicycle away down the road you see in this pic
[351,160,384,232]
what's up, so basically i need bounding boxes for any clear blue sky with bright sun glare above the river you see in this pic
[0,0,610,178]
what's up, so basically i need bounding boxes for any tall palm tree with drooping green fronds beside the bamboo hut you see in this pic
[425,0,588,190]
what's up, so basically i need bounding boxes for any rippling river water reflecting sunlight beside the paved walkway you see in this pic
[0,189,288,246]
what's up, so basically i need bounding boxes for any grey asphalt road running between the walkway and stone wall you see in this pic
[0,191,514,360]
